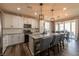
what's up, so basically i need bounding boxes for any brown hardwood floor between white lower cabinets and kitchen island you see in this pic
[4,43,31,56]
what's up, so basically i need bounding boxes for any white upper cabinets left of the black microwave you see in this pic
[3,14,23,28]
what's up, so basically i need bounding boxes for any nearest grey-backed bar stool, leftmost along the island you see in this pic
[36,37,52,56]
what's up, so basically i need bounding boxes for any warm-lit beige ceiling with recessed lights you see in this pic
[0,3,79,20]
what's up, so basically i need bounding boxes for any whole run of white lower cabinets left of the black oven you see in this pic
[3,34,24,52]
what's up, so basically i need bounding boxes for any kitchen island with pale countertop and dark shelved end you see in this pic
[29,33,63,55]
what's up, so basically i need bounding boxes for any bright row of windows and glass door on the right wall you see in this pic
[55,20,76,38]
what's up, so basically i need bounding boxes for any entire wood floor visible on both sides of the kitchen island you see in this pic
[4,40,79,56]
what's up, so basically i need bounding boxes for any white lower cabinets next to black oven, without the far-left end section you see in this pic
[8,34,24,45]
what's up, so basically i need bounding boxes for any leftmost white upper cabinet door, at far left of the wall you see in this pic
[3,14,13,28]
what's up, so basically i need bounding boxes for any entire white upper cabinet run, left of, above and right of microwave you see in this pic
[3,13,39,28]
